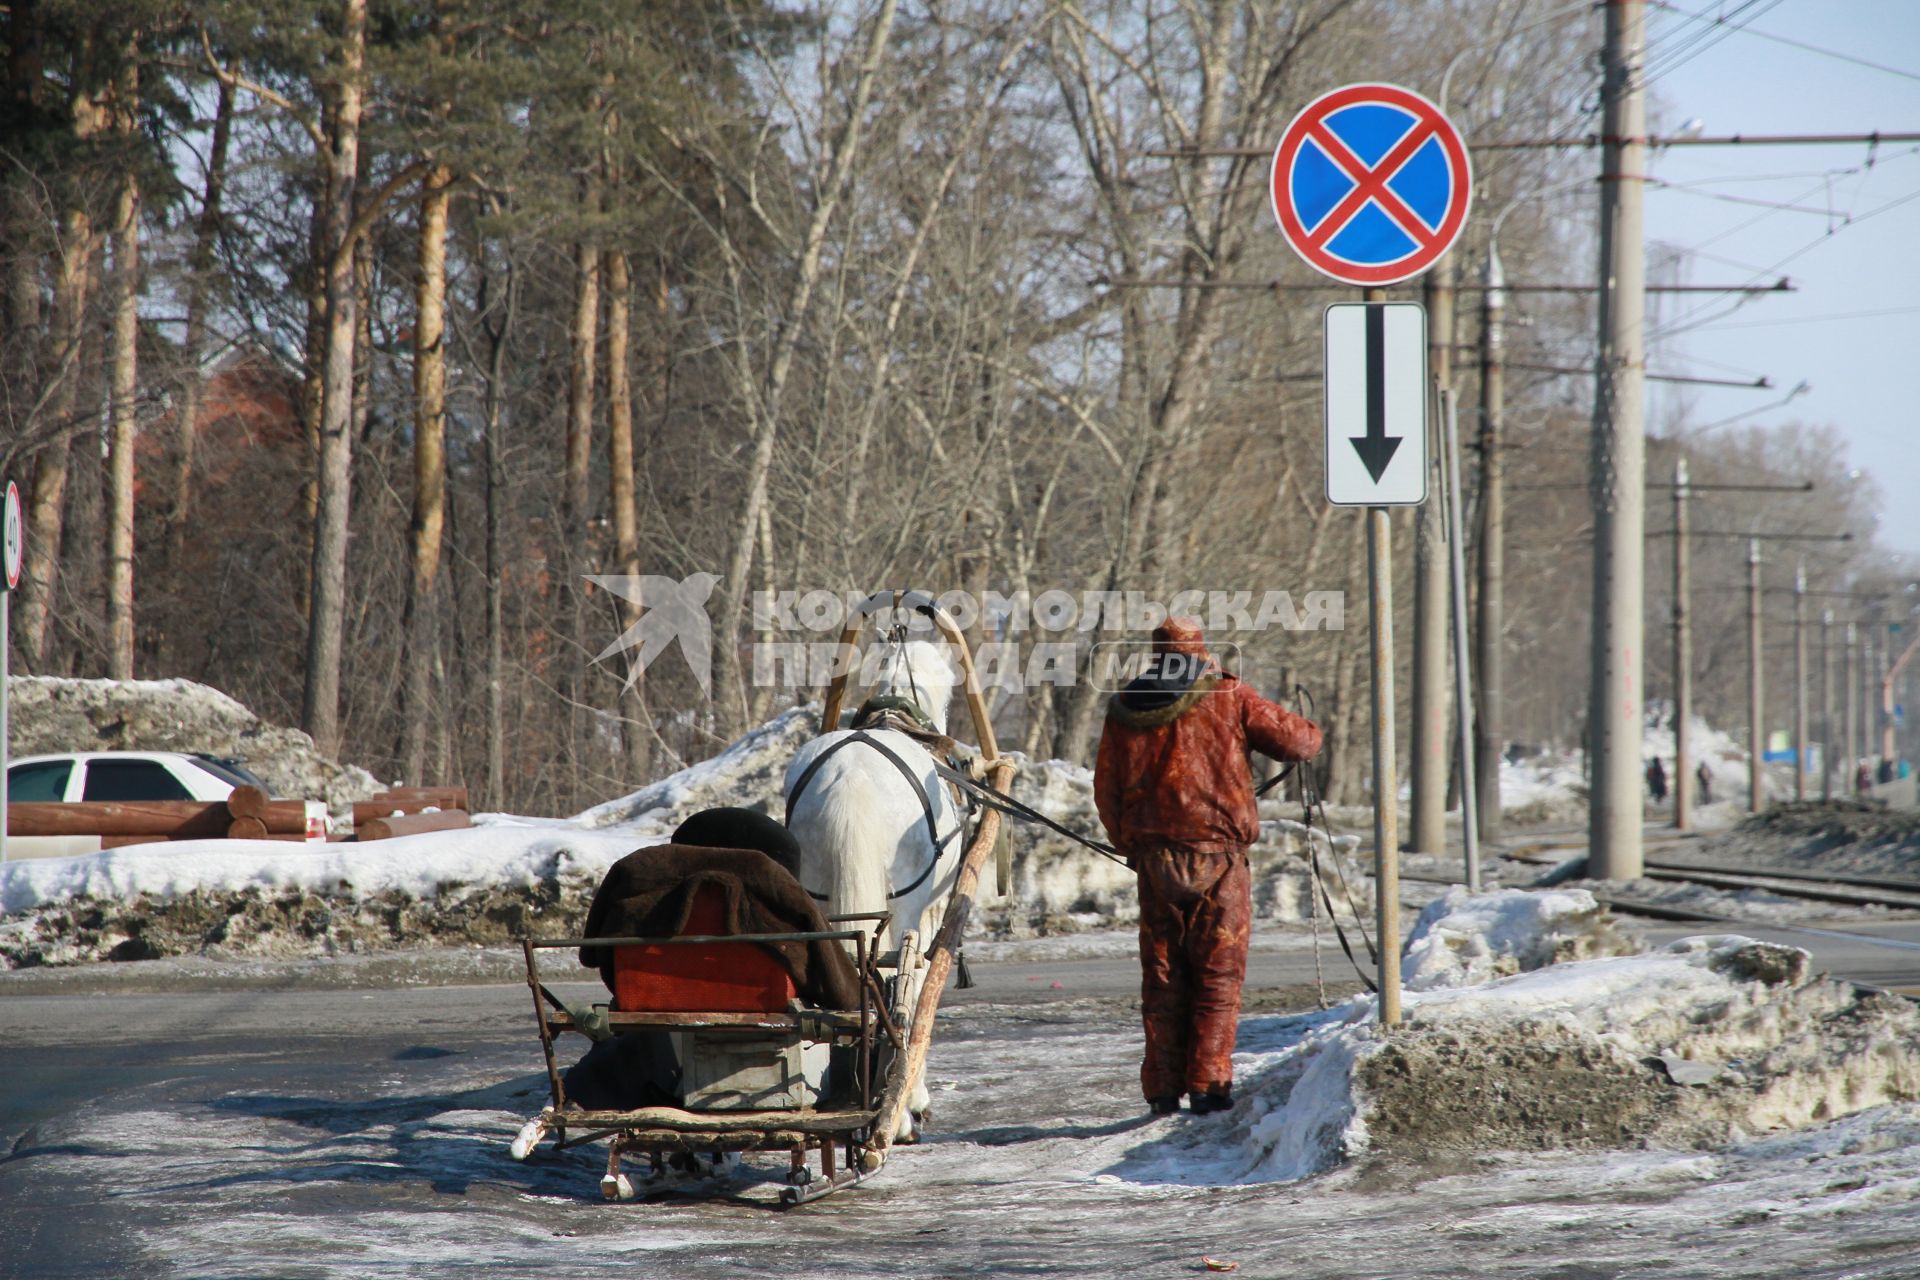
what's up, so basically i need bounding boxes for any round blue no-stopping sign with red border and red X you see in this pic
[1269,84,1473,286]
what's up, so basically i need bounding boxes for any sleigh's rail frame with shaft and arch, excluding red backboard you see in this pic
[515,591,1014,1205]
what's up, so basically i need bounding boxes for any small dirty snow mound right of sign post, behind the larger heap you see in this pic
[1400,885,1640,990]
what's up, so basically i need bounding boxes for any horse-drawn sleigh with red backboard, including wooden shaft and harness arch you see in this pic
[513,591,1014,1205]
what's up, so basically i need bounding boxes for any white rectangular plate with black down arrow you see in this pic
[1327,301,1427,507]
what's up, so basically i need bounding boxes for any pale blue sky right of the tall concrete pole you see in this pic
[1647,0,1920,553]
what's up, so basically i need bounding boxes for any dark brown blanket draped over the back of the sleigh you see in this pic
[580,844,860,1009]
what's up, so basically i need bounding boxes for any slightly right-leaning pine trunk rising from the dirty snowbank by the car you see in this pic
[301,0,367,756]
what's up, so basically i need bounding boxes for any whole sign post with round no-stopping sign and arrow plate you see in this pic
[1269,84,1473,1027]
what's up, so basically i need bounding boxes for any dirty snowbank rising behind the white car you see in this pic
[8,676,380,812]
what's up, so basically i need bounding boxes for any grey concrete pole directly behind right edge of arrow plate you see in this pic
[1407,270,1453,854]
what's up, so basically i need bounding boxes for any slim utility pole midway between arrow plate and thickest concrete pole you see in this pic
[1461,240,1507,841]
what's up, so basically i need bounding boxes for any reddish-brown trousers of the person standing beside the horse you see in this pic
[1133,850,1254,1098]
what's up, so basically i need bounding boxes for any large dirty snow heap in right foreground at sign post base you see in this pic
[1162,902,1920,1182]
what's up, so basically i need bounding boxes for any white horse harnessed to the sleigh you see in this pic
[785,641,966,1140]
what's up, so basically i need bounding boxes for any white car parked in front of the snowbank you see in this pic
[6,750,326,858]
